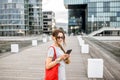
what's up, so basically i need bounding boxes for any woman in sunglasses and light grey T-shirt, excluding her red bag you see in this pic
[45,30,70,80]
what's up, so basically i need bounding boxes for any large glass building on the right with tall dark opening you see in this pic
[64,0,120,34]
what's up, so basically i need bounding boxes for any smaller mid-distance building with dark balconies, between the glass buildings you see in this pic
[43,11,56,34]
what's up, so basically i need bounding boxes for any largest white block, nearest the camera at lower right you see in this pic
[88,59,103,78]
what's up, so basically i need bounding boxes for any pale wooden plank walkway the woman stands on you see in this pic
[0,36,120,80]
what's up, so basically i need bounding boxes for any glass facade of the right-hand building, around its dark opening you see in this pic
[64,0,120,33]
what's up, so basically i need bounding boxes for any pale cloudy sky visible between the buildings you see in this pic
[42,0,68,23]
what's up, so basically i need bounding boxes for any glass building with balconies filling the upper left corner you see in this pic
[0,0,42,36]
